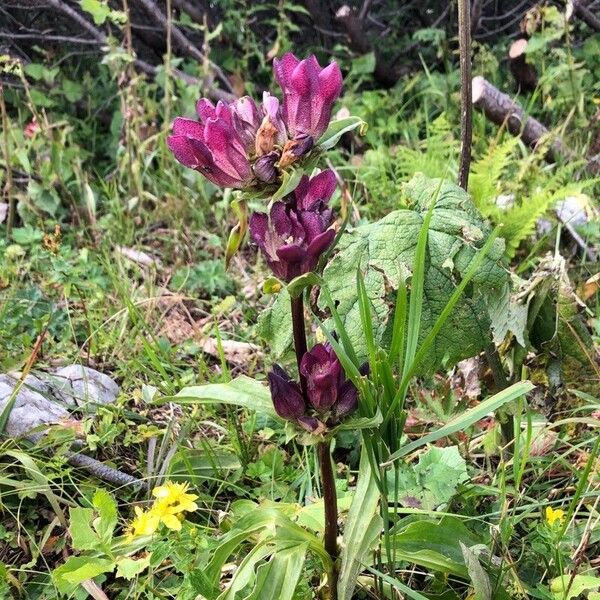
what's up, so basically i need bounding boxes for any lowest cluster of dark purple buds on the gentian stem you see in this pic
[269,343,364,433]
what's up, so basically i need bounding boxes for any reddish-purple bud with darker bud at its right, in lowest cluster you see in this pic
[300,343,358,418]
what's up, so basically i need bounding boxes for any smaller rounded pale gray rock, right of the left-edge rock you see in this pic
[48,365,119,407]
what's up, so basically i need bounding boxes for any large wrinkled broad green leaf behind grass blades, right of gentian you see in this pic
[324,175,508,371]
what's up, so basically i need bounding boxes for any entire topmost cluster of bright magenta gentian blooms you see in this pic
[167,52,342,189]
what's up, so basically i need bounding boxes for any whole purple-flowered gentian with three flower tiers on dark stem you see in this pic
[167,53,363,595]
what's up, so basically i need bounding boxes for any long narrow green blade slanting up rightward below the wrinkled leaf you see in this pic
[385,381,535,465]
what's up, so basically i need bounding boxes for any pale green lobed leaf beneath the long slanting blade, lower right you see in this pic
[388,446,469,510]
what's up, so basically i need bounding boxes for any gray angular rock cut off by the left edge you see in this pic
[0,373,69,437]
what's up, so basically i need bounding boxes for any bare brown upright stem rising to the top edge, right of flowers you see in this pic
[458,0,473,191]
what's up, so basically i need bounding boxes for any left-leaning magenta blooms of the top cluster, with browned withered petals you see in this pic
[167,93,287,189]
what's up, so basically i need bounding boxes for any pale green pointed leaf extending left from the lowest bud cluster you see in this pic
[163,375,279,419]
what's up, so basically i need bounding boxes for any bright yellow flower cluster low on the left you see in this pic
[127,481,198,540]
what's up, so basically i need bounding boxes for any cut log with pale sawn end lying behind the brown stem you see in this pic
[472,76,568,160]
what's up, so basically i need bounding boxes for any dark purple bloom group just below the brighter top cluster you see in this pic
[250,170,336,282]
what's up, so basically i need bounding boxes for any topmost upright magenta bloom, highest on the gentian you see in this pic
[273,52,342,141]
